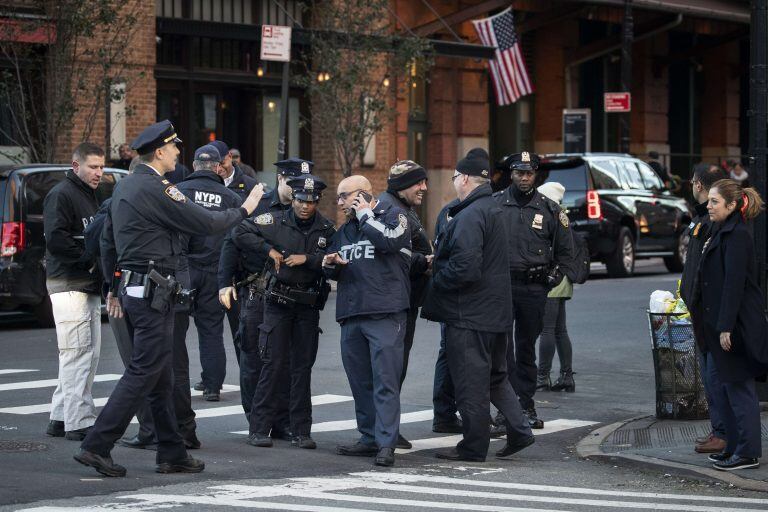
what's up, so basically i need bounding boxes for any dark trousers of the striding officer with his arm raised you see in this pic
[82,295,187,462]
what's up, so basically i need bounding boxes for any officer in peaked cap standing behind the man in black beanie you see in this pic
[494,151,573,428]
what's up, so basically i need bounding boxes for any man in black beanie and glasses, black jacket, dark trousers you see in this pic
[422,149,534,462]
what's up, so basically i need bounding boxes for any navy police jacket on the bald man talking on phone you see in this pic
[325,203,411,322]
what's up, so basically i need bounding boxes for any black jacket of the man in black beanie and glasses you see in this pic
[421,184,512,332]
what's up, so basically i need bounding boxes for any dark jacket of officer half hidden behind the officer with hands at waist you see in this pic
[217,189,290,289]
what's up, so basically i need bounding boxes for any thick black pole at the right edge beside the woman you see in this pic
[748,0,768,297]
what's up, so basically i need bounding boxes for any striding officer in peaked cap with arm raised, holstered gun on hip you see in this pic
[75,121,262,476]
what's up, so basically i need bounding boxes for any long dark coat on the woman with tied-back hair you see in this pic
[699,211,768,382]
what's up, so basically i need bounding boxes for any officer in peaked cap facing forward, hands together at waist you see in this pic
[232,174,336,449]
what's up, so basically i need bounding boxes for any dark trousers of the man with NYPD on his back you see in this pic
[190,268,227,391]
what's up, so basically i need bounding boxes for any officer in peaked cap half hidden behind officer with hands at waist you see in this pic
[219,158,314,432]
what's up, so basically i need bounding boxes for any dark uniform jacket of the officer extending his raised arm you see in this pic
[102,164,247,273]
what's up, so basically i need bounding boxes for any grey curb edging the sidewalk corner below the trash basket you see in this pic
[576,414,768,492]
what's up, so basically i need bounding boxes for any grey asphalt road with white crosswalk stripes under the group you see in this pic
[0,261,768,512]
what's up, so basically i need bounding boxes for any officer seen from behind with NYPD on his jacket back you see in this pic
[177,144,242,402]
